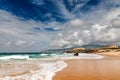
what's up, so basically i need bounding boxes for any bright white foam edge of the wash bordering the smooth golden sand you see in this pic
[0,61,67,80]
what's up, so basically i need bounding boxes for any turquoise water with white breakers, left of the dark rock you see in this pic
[0,52,66,60]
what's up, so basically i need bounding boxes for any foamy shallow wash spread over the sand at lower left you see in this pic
[0,60,67,80]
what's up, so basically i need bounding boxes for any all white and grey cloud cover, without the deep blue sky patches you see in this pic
[0,0,120,51]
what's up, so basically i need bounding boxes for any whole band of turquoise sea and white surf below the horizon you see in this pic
[0,52,104,60]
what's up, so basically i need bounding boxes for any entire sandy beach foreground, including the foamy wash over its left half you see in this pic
[0,52,120,80]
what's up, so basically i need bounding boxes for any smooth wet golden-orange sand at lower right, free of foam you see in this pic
[53,57,120,80]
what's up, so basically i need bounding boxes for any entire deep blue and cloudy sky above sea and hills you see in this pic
[0,0,120,52]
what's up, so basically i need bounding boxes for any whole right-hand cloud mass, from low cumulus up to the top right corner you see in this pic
[50,0,120,47]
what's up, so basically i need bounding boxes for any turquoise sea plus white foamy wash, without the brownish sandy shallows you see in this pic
[0,52,103,80]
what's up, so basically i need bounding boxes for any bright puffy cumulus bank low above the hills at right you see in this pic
[52,24,120,48]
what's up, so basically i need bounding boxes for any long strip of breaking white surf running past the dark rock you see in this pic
[0,53,104,60]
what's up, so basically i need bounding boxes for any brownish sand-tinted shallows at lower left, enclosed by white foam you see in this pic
[0,62,39,78]
